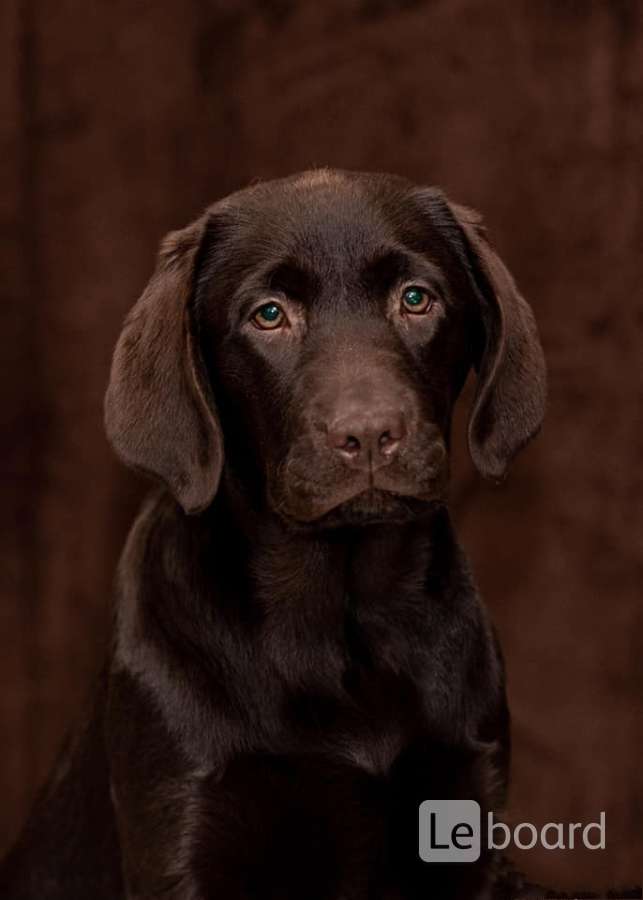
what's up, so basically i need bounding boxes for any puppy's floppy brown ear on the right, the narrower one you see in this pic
[422,191,547,480]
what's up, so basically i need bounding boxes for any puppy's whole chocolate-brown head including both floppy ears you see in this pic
[106,170,545,526]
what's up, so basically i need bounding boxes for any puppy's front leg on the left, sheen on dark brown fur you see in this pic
[106,668,251,900]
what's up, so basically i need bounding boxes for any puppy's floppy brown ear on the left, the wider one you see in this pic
[105,214,223,513]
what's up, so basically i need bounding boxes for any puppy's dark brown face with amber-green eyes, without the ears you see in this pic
[195,174,477,524]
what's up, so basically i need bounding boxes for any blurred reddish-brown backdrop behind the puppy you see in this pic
[0,0,643,886]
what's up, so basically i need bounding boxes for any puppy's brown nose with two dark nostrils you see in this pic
[328,409,406,469]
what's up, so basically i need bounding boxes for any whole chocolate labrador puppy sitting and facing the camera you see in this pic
[0,170,545,900]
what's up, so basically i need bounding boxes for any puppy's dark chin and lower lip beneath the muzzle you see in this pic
[282,487,443,530]
